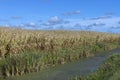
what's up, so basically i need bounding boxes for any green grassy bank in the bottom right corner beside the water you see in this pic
[72,54,120,80]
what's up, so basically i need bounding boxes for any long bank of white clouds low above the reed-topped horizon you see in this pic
[0,16,120,33]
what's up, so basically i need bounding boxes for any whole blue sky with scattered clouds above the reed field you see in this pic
[0,0,120,33]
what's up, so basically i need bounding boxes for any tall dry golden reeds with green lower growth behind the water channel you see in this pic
[0,28,120,78]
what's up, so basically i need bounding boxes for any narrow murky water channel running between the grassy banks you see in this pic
[12,49,120,80]
